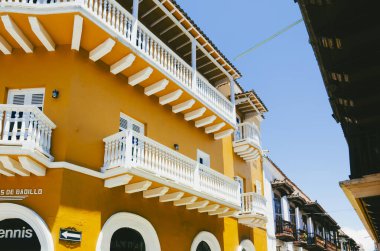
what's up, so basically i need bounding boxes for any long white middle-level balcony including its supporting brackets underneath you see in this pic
[102,130,241,212]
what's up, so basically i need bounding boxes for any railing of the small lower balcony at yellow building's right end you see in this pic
[241,192,266,216]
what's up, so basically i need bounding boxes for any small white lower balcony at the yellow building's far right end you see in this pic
[237,192,267,228]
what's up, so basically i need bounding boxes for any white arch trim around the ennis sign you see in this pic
[0,203,54,251]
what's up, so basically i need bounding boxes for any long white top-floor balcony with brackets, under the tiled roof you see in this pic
[0,0,236,129]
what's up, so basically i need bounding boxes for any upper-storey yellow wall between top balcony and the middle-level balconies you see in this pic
[0,46,227,172]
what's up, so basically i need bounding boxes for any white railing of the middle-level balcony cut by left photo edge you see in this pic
[0,104,55,158]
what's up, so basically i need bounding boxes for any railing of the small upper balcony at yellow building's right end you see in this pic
[234,122,261,149]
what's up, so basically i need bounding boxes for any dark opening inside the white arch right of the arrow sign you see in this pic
[111,227,145,251]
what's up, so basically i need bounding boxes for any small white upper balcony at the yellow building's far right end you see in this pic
[233,122,261,161]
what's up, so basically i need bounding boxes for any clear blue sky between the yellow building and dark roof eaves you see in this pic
[177,0,370,249]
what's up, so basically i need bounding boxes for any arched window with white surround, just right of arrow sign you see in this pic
[96,213,161,251]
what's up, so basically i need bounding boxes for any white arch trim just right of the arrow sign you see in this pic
[96,212,161,251]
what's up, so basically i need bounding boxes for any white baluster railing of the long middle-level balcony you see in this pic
[103,130,241,207]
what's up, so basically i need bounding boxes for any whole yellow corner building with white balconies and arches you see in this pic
[0,0,267,251]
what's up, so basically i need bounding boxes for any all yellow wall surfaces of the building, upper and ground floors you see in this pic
[0,13,266,251]
